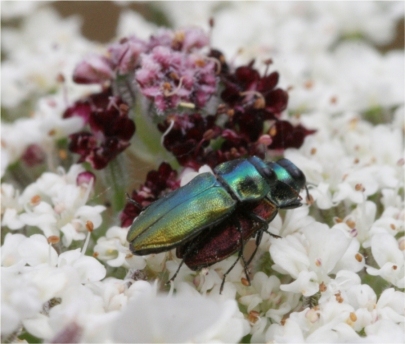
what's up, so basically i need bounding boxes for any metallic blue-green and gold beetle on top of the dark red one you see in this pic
[127,156,305,255]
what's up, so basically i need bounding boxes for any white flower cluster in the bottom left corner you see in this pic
[1,233,106,338]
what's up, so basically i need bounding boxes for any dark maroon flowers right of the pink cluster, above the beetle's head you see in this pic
[158,50,314,170]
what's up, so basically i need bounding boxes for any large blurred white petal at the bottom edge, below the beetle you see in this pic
[113,295,240,343]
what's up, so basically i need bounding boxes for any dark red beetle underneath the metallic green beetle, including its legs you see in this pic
[172,159,309,293]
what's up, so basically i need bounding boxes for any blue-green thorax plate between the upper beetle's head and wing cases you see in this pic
[214,158,270,202]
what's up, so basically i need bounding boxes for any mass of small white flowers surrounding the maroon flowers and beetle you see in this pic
[1,2,405,343]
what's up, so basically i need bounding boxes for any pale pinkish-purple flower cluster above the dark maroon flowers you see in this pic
[73,28,217,114]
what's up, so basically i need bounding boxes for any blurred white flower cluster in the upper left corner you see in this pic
[1,6,97,110]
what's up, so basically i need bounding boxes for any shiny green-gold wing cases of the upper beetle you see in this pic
[127,173,237,255]
